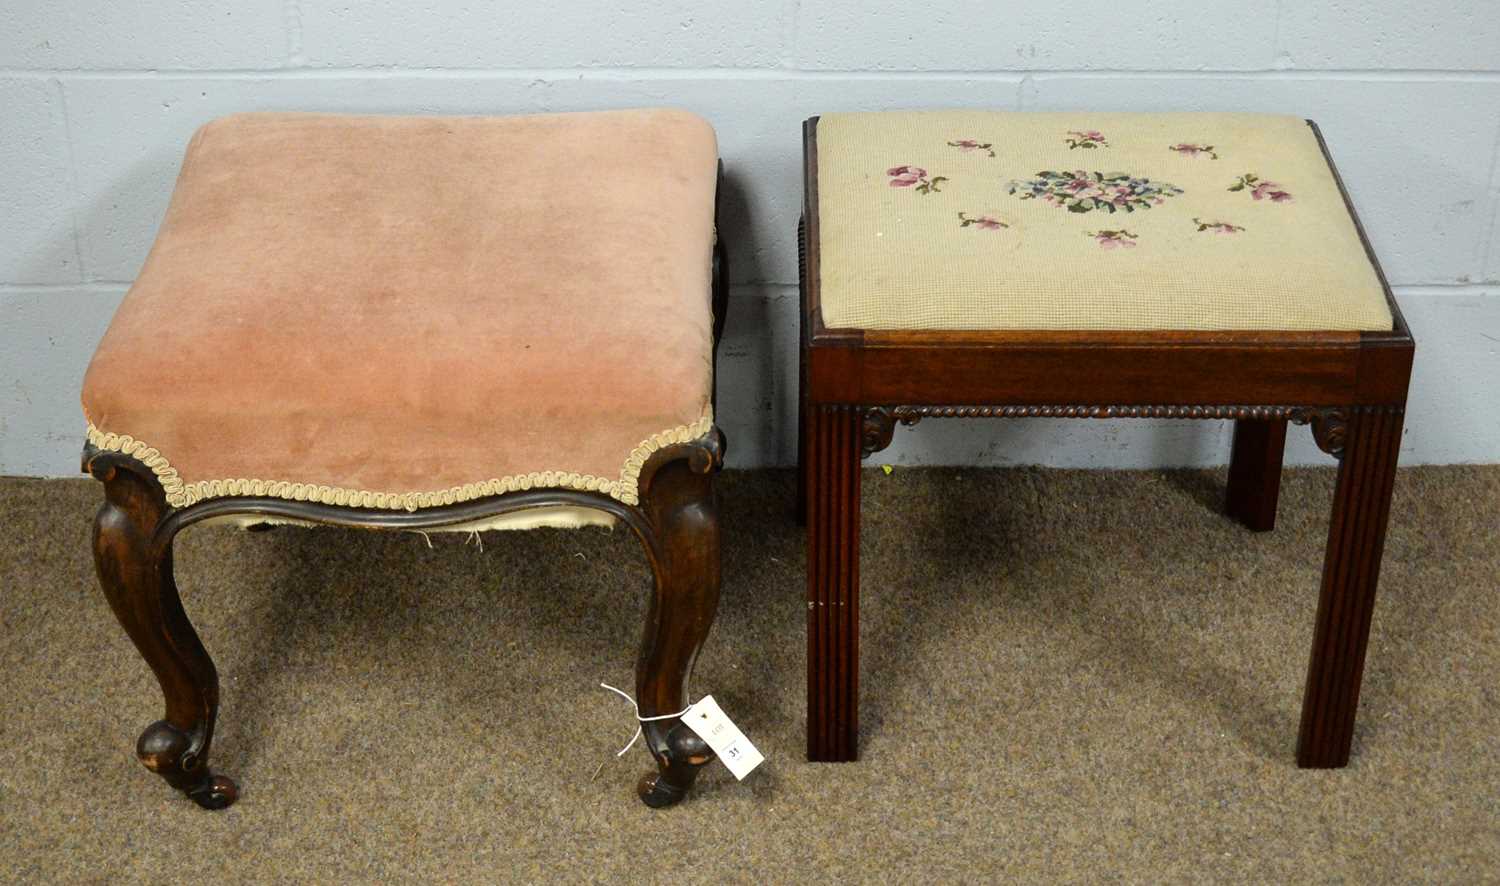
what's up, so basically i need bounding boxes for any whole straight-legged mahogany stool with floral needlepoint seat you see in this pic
[798,111,1415,768]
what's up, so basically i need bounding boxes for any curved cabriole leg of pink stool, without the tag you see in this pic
[86,451,239,810]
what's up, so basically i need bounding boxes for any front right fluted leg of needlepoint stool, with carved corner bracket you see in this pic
[1298,406,1404,768]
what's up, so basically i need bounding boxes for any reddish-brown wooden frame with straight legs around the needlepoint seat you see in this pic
[798,117,1415,768]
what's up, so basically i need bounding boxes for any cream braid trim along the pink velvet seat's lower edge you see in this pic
[89,411,714,511]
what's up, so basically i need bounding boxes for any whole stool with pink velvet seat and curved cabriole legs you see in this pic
[83,111,728,808]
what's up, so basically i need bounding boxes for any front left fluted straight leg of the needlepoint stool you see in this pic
[803,405,864,762]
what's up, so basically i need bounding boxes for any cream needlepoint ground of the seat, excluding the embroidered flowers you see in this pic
[818,111,1392,330]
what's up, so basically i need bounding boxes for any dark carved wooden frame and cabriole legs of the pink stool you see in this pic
[83,173,729,810]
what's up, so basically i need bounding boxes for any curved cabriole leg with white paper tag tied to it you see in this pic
[636,460,719,807]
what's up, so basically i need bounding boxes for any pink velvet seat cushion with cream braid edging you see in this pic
[83,109,717,510]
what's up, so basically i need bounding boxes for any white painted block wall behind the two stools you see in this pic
[0,0,1500,475]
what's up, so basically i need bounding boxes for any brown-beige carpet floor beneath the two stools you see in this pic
[0,466,1500,883]
